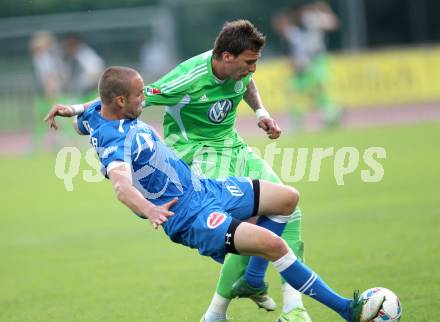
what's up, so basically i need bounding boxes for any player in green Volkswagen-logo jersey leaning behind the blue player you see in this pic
[45,20,311,322]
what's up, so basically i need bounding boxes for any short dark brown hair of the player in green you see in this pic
[212,20,266,59]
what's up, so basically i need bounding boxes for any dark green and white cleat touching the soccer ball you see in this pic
[349,291,385,322]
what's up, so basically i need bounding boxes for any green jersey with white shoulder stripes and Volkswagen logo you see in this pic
[144,51,252,150]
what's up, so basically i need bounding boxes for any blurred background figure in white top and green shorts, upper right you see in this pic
[274,1,342,129]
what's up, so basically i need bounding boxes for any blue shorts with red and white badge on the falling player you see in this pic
[166,177,259,263]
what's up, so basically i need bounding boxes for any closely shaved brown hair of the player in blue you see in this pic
[98,66,138,104]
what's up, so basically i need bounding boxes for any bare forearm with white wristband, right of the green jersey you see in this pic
[244,79,281,139]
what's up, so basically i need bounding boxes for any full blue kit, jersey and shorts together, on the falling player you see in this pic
[78,102,254,261]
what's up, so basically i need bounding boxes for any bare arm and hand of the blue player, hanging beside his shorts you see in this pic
[108,162,177,229]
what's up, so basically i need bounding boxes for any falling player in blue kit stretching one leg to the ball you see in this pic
[46,67,384,322]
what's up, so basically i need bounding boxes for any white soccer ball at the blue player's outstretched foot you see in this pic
[361,287,402,322]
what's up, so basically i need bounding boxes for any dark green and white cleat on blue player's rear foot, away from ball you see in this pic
[232,276,277,311]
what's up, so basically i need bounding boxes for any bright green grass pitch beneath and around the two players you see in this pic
[0,123,440,322]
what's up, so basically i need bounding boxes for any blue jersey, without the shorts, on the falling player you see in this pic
[78,103,200,205]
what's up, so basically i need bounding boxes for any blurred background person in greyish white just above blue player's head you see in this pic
[63,35,105,100]
